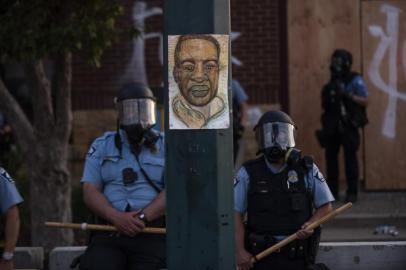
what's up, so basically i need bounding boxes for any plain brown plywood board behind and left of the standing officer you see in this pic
[288,0,361,179]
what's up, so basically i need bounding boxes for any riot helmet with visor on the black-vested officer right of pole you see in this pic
[254,111,295,162]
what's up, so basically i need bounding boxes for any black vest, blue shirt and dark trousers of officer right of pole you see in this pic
[234,157,334,270]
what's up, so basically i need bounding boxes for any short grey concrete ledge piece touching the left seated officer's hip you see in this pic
[49,246,86,270]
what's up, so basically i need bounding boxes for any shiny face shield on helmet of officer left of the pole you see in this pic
[117,98,156,127]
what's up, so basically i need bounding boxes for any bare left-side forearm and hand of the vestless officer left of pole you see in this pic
[83,182,145,236]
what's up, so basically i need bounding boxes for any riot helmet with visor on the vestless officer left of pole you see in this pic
[116,83,156,143]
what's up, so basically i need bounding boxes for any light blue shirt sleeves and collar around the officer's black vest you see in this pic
[234,159,334,213]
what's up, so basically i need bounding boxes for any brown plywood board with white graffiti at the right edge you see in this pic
[361,1,406,190]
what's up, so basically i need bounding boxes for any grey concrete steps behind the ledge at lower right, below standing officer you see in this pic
[321,192,406,242]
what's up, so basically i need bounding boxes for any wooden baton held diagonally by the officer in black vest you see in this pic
[251,202,352,263]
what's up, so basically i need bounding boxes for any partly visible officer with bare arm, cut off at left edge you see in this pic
[0,167,23,270]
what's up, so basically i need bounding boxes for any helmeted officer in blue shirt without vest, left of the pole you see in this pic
[80,83,166,270]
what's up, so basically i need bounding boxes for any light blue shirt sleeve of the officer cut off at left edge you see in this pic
[0,167,23,214]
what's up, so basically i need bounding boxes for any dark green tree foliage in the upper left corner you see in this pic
[0,0,137,66]
